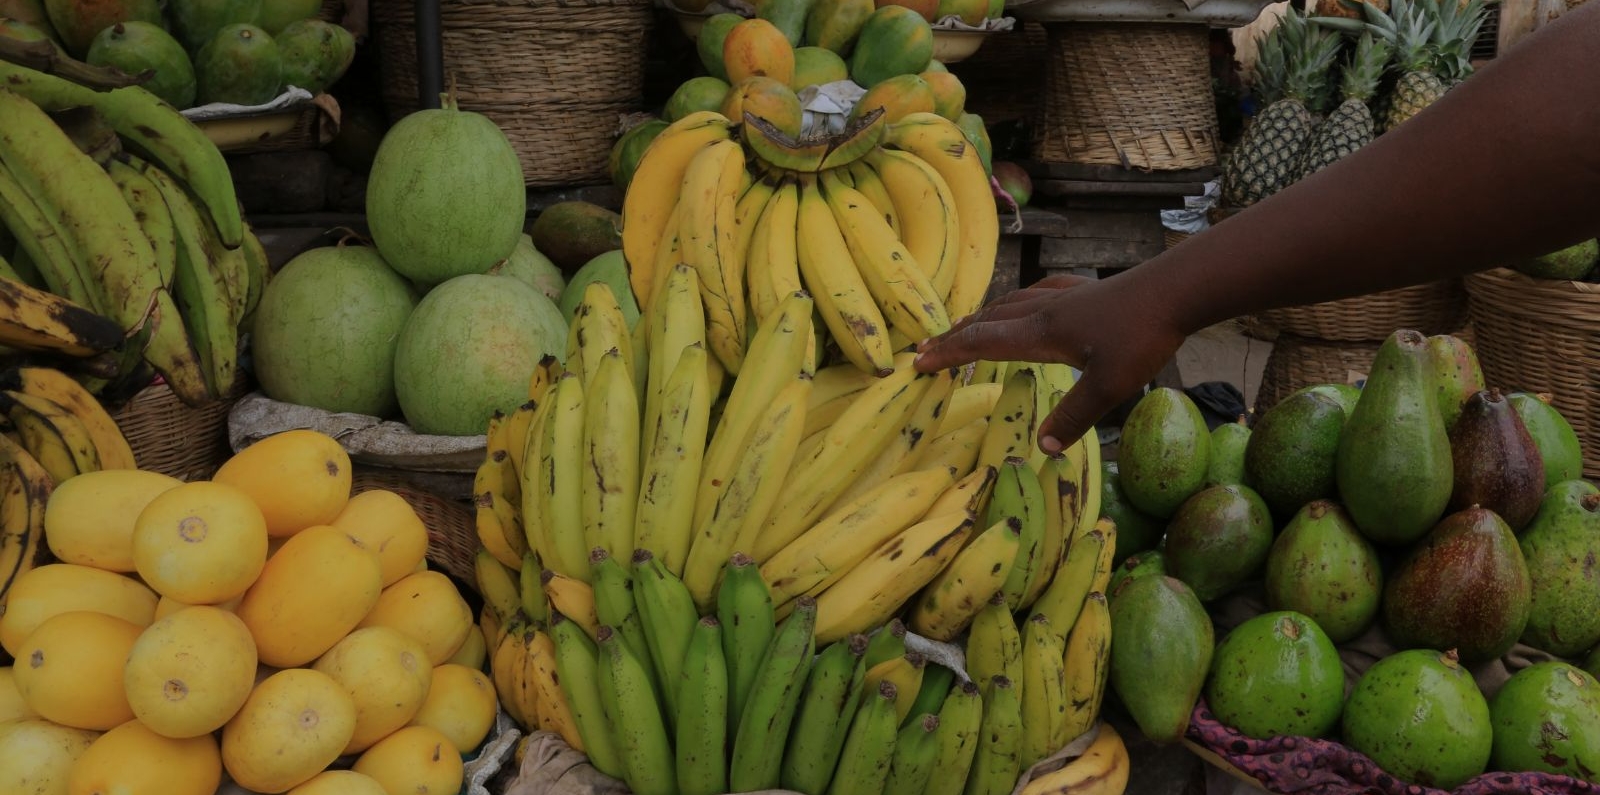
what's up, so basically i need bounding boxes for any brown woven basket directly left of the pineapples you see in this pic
[1034,22,1218,171]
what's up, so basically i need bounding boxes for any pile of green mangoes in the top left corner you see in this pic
[0,0,355,110]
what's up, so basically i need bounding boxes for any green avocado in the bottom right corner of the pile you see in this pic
[1490,662,1600,784]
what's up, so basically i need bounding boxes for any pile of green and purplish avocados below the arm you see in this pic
[1101,331,1600,789]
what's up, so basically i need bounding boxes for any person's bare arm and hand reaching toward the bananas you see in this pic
[917,3,1600,454]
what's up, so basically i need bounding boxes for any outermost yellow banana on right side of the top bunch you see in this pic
[886,112,1000,318]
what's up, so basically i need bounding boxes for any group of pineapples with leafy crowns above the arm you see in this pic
[1222,0,1488,208]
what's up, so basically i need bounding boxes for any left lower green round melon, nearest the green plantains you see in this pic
[251,246,418,417]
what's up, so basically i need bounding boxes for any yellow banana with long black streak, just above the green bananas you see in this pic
[816,510,973,643]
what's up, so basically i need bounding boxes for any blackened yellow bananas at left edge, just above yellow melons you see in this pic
[0,366,136,614]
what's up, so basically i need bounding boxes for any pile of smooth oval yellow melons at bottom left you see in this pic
[0,430,494,795]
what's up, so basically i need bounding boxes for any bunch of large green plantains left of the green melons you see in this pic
[0,62,267,405]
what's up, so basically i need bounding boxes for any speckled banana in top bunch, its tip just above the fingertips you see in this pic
[822,173,950,340]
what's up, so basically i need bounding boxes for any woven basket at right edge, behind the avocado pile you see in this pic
[1467,269,1600,478]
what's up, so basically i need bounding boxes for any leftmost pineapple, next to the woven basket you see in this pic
[1222,11,1339,206]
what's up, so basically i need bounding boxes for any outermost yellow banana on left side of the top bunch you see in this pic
[622,110,733,309]
